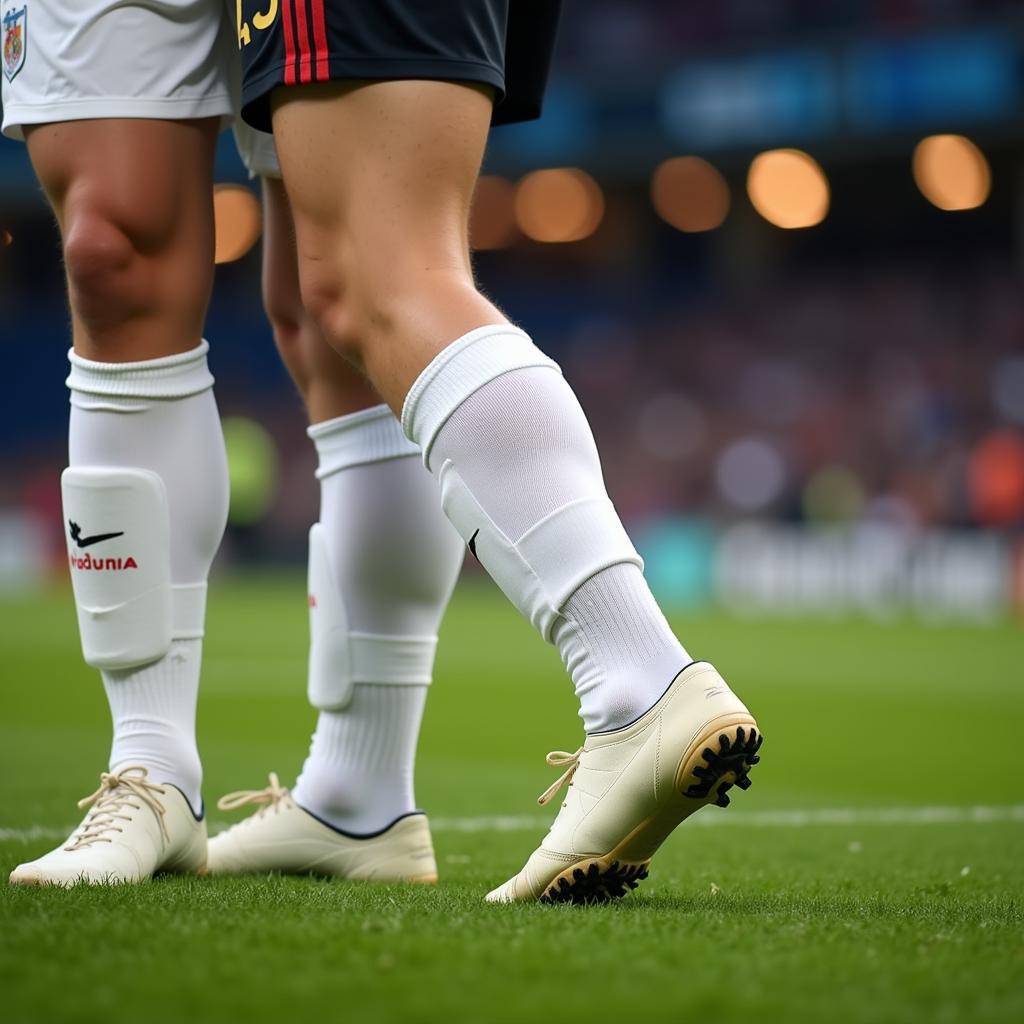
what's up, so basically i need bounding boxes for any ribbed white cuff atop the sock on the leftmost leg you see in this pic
[65,341,213,398]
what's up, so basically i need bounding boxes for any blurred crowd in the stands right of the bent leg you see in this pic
[563,268,1024,528]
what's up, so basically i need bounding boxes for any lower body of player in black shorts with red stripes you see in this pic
[240,0,761,901]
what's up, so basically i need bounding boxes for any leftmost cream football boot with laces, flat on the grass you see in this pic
[10,765,206,888]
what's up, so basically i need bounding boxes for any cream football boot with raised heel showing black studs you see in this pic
[486,662,762,903]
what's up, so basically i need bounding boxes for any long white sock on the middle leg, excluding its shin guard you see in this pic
[293,406,465,835]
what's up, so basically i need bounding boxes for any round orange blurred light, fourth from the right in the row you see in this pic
[515,167,604,242]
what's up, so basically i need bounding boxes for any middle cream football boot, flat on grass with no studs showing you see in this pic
[208,772,437,883]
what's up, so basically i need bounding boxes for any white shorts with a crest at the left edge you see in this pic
[0,0,238,138]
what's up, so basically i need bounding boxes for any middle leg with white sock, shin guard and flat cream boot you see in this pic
[210,148,463,879]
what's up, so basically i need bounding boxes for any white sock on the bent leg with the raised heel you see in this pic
[402,325,691,732]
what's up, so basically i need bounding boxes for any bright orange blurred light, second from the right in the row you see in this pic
[746,150,828,228]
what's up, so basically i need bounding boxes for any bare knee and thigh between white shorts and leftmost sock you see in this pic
[27,118,218,361]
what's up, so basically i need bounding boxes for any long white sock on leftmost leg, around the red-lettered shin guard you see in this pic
[68,342,228,812]
